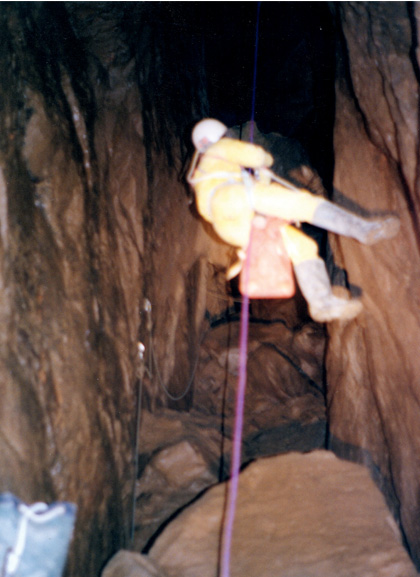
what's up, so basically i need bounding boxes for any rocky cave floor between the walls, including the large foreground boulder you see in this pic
[102,321,417,577]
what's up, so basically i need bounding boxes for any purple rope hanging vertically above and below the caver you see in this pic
[220,2,261,577]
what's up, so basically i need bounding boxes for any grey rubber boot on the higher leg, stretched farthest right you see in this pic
[311,201,400,244]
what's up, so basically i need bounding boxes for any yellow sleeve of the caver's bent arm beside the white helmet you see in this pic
[206,138,274,168]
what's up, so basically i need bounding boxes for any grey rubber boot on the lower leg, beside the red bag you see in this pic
[294,258,363,323]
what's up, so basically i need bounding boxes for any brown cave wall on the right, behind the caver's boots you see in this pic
[327,2,420,566]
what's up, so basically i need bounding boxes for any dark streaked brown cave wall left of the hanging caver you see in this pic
[0,3,213,575]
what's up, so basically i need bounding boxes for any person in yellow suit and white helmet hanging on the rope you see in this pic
[187,118,399,322]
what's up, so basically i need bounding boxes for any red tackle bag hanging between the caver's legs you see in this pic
[239,215,295,299]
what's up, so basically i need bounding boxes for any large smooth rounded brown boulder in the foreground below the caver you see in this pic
[103,451,417,577]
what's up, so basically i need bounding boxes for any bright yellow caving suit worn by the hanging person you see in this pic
[188,138,324,265]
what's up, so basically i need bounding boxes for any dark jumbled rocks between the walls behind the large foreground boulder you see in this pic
[135,322,326,551]
